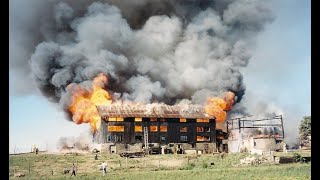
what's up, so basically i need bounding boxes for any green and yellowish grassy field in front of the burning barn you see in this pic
[9,154,311,180]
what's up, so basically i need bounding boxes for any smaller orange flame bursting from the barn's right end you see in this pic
[204,91,235,122]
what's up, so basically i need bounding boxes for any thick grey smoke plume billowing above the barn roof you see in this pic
[10,0,273,121]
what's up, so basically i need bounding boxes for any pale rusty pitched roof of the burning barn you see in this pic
[97,104,215,119]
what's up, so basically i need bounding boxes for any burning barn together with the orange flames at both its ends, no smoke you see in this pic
[68,74,235,153]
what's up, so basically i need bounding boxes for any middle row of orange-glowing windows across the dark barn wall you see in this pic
[108,126,210,132]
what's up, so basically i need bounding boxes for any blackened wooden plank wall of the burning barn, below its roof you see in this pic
[103,118,216,145]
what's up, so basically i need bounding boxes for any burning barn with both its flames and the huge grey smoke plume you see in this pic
[10,0,274,155]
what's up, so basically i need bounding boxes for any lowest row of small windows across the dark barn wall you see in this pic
[107,135,210,142]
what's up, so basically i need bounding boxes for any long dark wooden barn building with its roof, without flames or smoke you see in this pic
[94,104,228,153]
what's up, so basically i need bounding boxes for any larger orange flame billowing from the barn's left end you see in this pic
[68,73,112,132]
